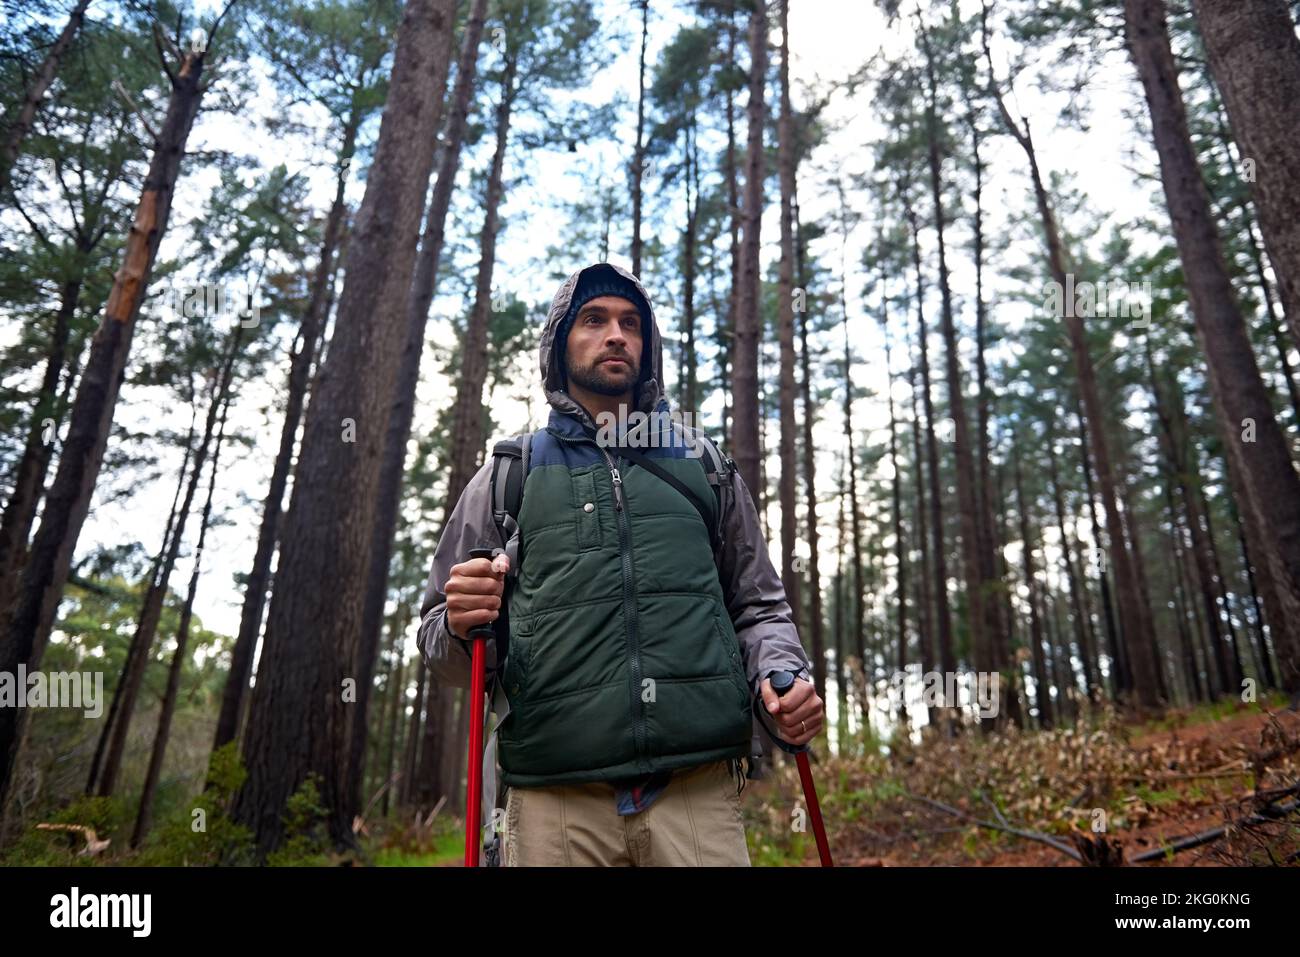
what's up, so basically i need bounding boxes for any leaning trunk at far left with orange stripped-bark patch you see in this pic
[0,51,204,807]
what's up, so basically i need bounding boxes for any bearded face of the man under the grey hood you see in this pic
[564,295,642,395]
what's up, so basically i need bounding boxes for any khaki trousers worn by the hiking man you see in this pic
[502,761,749,867]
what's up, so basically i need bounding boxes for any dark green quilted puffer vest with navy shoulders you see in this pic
[498,410,753,788]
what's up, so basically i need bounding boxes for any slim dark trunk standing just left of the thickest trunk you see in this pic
[212,104,361,750]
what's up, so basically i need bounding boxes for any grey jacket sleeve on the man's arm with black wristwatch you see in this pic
[718,460,813,697]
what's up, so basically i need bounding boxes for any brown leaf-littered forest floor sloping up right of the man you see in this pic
[745,698,1300,867]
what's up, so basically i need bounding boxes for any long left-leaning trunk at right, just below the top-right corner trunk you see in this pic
[1125,0,1300,698]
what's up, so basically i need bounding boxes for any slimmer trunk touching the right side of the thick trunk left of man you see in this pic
[348,0,488,826]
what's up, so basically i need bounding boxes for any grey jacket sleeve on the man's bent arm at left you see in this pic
[416,456,501,688]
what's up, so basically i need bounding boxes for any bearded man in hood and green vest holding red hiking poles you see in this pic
[417,263,823,866]
